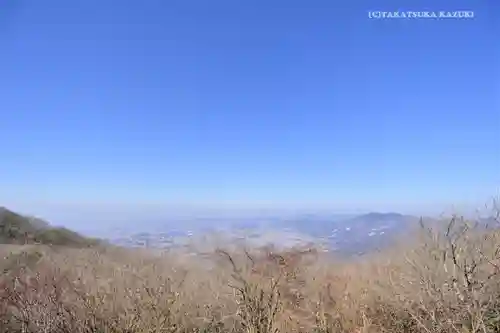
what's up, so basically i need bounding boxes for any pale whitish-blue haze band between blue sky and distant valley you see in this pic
[2,200,491,231]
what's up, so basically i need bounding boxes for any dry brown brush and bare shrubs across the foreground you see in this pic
[0,213,500,333]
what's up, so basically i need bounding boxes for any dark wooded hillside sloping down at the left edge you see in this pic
[0,207,100,247]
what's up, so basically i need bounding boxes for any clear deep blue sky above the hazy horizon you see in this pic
[0,0,500,217]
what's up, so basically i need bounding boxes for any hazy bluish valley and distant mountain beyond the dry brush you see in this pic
[110,213,419,255]
